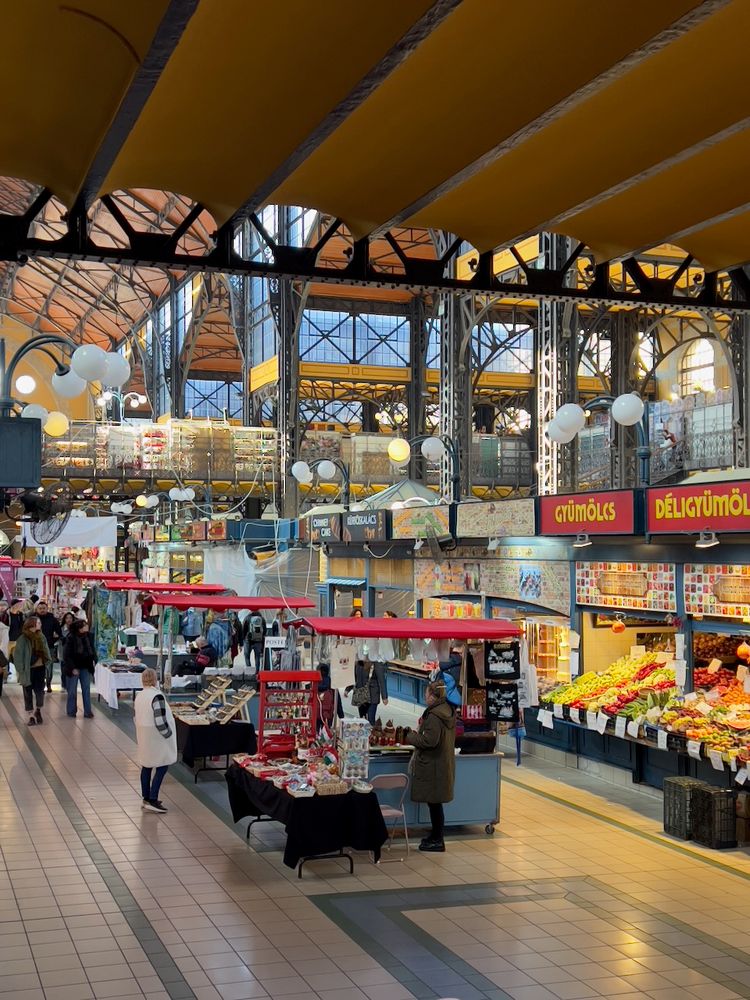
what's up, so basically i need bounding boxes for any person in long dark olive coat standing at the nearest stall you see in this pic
[404,681,456,853]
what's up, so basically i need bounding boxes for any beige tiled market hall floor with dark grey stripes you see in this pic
[0,685,750,1000]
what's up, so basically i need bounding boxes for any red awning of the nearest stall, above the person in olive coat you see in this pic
[304,618,521,639]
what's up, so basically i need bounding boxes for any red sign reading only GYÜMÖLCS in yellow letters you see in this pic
[539,490,635,535]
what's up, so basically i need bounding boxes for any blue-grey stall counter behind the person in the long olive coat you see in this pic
[369,750,504,834]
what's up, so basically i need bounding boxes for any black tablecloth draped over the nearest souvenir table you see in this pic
[226,764,388,868]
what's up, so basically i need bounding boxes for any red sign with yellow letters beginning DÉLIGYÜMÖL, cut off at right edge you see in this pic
[646,483,750,535]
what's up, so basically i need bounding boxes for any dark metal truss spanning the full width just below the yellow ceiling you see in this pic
[0,190,750,312]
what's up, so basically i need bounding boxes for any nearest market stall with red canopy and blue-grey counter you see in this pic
[296,618,521,833]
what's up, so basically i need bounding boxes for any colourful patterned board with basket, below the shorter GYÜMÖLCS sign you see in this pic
[576,562,677,613]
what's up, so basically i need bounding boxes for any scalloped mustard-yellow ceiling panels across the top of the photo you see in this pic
[0,0,750,270]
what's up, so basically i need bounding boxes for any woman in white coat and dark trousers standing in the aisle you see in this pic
[135,668,177,813]
